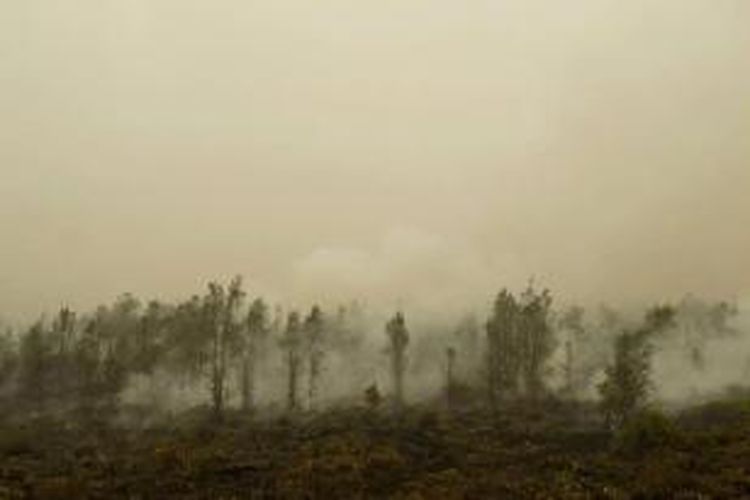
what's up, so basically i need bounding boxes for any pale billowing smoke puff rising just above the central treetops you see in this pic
[291,227,521,320]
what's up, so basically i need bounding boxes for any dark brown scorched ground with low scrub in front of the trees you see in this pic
[0,402,750,499]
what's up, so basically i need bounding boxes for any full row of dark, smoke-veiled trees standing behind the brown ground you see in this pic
[0,277,738,427]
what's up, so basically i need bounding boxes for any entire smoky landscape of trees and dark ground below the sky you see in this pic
[0,276,750,498]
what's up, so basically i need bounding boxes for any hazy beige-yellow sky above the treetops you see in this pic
[0,0,750,317]
